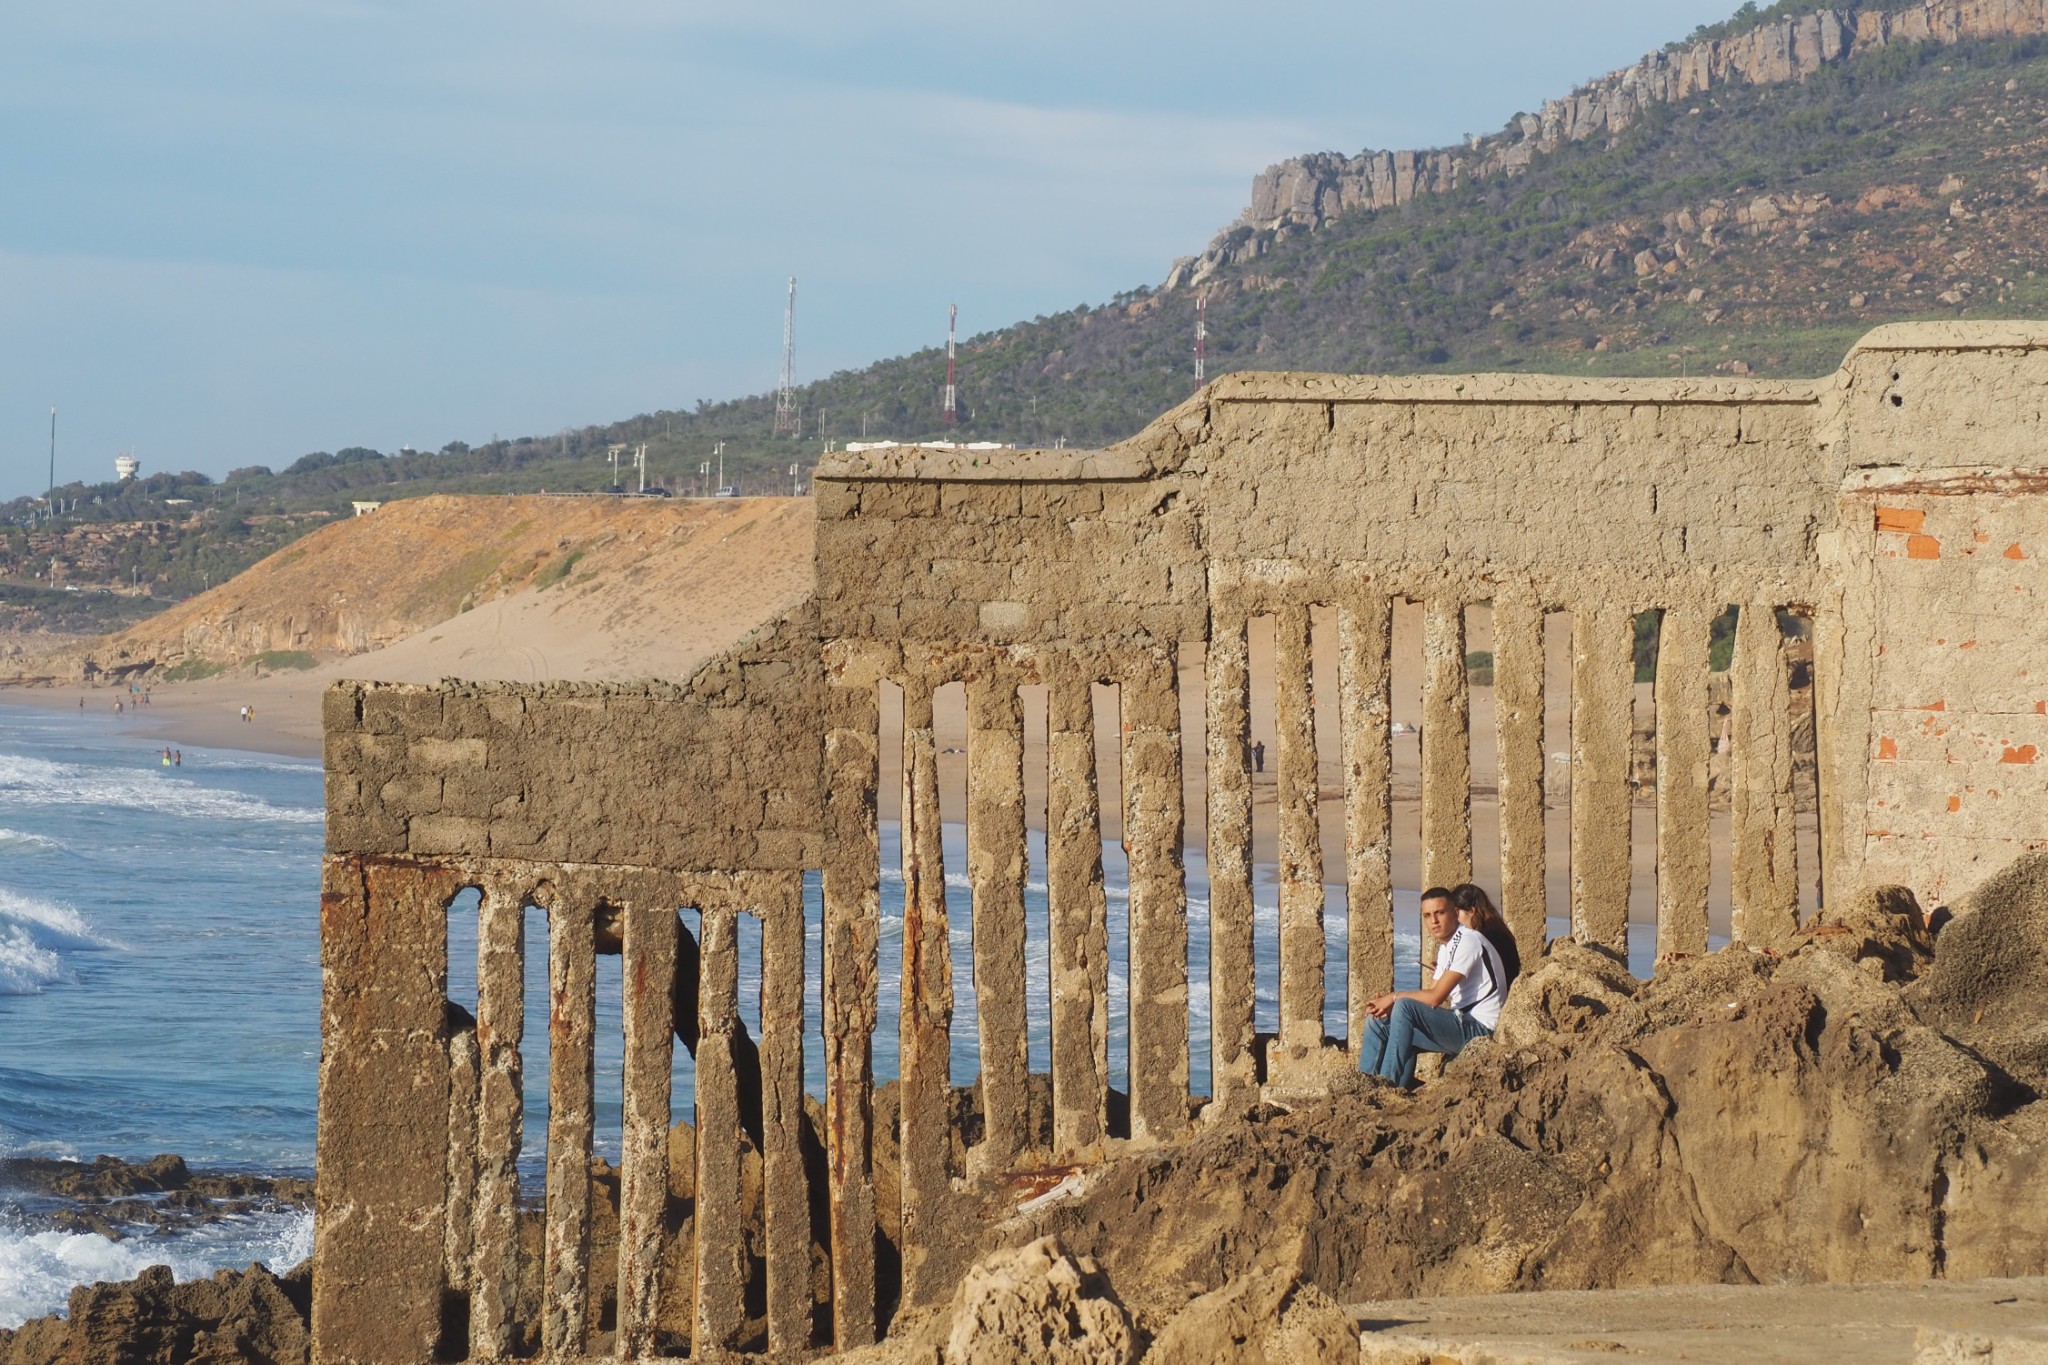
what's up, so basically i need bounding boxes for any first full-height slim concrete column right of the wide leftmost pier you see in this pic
[469,882,526,1359]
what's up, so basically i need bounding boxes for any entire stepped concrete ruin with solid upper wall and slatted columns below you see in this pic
[313,323,2048,1365]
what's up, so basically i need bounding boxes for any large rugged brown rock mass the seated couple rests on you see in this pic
[978,875,2048,1324]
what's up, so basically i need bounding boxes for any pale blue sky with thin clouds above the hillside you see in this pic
[0,0,1735,497]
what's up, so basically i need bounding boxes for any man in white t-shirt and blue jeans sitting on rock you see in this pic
[1360,886,1507,1091]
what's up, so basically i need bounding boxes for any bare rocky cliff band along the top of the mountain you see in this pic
[1165,0,2048,291]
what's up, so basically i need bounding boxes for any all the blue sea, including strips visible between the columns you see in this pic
[0,706,1653,1326]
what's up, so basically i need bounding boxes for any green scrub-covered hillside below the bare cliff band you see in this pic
[12,0,2048,638]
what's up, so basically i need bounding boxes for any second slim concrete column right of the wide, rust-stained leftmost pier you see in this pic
[541,886,598,1355]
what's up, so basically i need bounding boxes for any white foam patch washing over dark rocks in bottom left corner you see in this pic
[0,1209,313,1328]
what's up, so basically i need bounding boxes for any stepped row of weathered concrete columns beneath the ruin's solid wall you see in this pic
[322,591,1798,1357]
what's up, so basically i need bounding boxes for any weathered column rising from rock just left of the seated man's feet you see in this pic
[1274,606,1325,1060]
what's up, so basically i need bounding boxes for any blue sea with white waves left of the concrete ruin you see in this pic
[0,706,322,1326]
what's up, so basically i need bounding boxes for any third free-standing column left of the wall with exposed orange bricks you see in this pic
[1571,602,1634,952]
